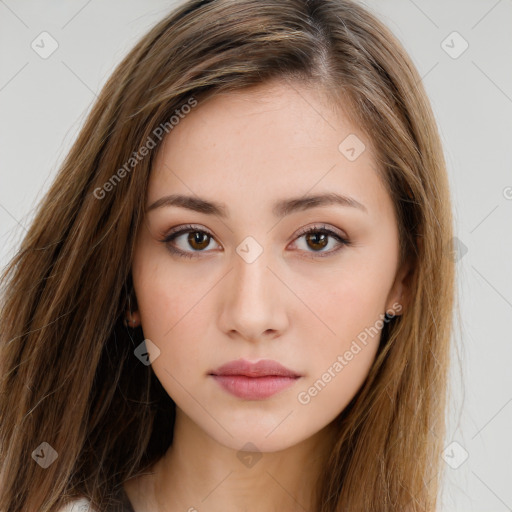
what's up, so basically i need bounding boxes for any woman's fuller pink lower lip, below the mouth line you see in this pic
[212,375,298,400]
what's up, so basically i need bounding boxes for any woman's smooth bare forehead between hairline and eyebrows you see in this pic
[148,82,390,221]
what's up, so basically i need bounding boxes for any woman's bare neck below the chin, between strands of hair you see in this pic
[144,408,334,512]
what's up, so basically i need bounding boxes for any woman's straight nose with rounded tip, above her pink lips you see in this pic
[215,246,290,342]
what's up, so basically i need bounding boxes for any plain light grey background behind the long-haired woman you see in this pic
[0,0,512,512]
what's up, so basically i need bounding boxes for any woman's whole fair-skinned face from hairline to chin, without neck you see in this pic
[132,79,405,451]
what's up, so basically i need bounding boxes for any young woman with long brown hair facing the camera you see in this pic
[0,0,454,512]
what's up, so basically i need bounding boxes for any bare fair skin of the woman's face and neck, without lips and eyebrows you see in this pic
[125,78,408,512]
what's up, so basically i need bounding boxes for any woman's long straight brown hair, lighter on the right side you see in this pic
[0,0,454,512]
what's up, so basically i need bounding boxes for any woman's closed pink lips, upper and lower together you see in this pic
[210,359,301,400]
